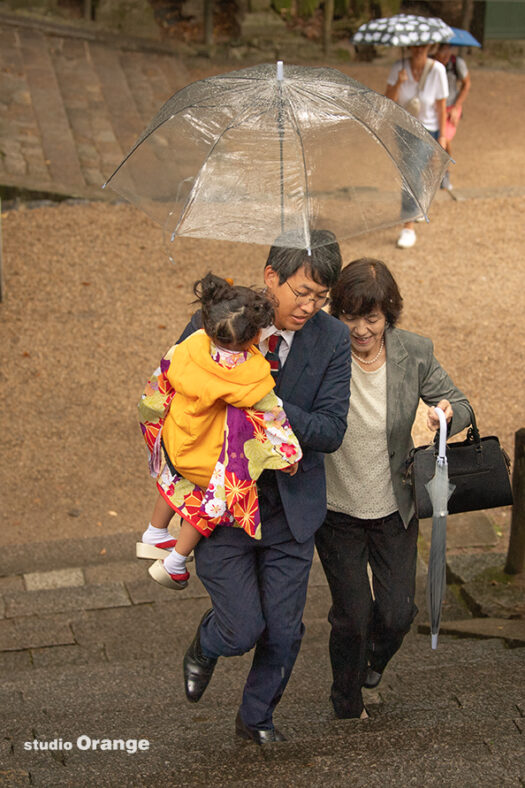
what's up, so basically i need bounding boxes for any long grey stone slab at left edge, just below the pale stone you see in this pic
[5,583,131,618]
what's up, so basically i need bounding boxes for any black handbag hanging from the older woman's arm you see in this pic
[405,408,512,519]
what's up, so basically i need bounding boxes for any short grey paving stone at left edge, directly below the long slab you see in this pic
[0,617,75,651]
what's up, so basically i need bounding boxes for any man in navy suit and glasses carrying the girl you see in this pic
[181,231,350,744]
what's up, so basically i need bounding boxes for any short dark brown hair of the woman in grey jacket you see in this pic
[330,257,403,326]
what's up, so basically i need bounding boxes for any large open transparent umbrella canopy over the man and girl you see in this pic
[107,64,449,249]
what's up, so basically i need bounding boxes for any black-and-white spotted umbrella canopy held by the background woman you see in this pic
[352,14,452,47]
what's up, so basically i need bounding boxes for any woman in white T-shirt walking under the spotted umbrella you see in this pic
[385,45,448,249]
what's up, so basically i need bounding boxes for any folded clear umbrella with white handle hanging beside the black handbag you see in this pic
[425,408,455,649]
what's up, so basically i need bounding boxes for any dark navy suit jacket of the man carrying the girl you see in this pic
[179,312,350,542]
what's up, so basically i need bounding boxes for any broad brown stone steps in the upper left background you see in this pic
[0,21,189,199]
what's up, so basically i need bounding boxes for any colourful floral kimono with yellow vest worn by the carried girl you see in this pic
[139,331,302,539]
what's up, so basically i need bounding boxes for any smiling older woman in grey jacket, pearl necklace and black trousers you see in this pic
[316,258,470,717]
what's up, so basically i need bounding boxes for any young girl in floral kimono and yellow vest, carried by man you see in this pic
[137,273,302,589]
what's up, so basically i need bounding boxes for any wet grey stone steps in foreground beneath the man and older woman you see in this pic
[0,534,525,788]
